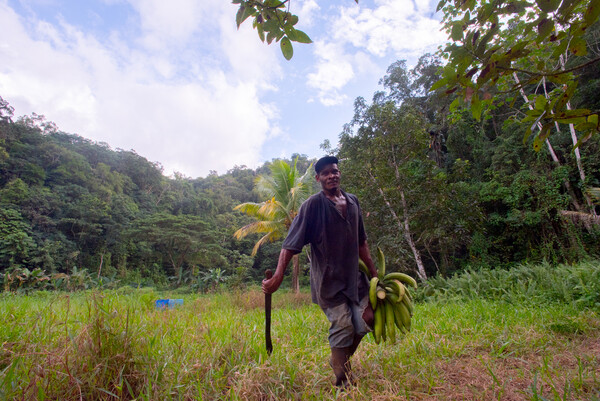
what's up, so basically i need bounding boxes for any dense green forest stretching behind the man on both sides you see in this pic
[0,24,600,290]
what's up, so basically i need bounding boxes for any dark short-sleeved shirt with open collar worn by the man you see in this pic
[283,191,368,308]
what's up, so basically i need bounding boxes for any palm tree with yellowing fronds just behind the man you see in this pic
[233,158,312,292]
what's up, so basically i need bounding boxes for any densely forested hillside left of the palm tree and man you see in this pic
[0,100,318,288]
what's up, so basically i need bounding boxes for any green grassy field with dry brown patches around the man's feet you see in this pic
[0,288,600,400]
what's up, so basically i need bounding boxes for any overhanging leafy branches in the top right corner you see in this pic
[432,0,600,150]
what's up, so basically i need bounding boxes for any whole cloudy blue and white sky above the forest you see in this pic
[0,0,446,178]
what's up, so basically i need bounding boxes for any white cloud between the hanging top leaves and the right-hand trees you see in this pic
[308,0,446,106]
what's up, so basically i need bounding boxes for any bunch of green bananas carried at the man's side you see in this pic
[358,248,417,344]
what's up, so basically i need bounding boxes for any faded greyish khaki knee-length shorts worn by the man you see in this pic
[321,295,372,348]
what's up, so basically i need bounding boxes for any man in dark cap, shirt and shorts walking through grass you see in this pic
[262,156,377,387]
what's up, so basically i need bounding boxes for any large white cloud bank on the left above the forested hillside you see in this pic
[0,0,280,176]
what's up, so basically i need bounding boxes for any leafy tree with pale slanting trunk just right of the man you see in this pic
[338,94,479,280]
